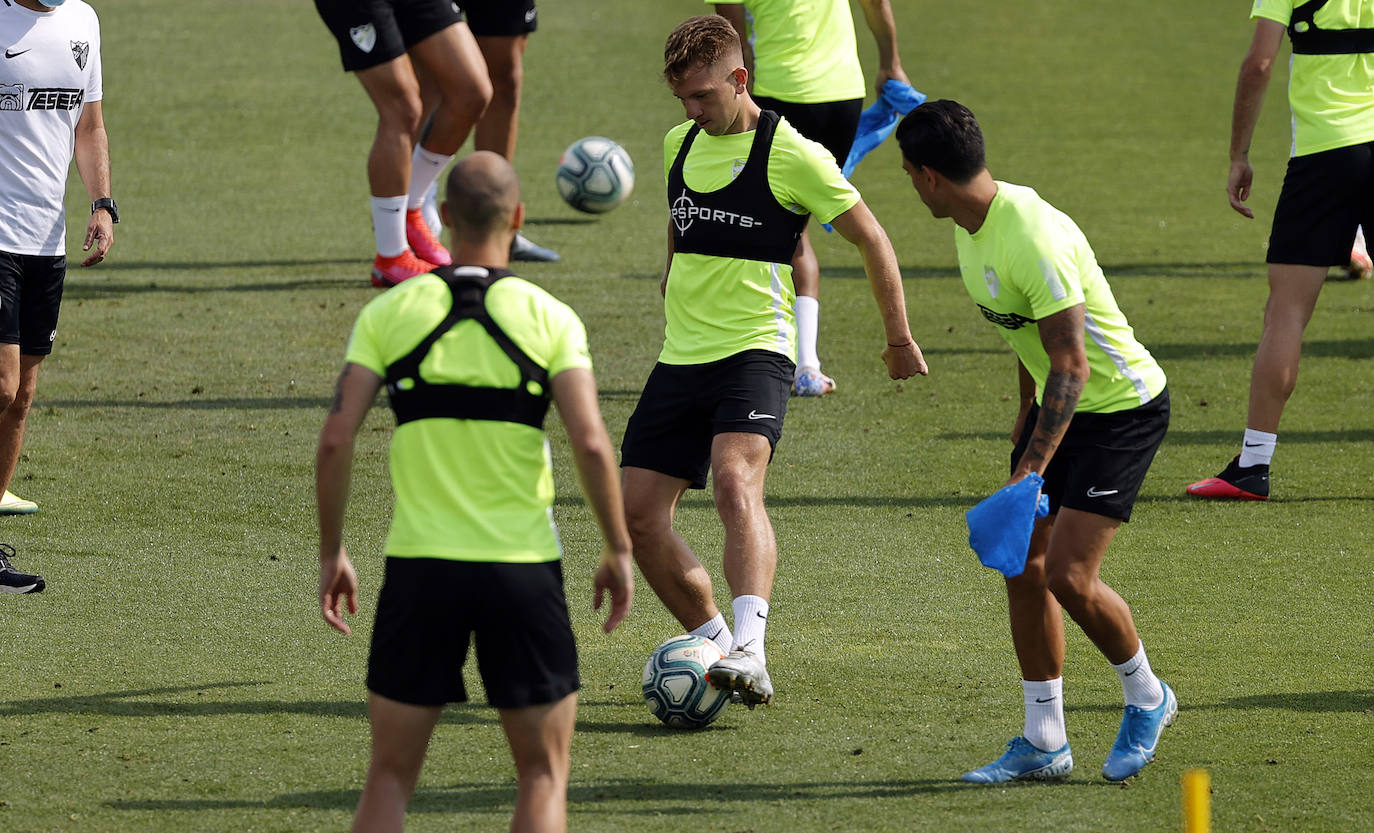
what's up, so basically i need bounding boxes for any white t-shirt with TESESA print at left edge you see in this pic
[0,0,104,254]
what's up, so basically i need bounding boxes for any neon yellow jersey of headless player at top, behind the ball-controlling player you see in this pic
[708,0,864,104]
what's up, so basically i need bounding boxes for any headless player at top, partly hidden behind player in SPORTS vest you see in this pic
[709,0,907,396]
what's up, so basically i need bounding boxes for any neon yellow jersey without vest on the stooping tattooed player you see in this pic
[955,181,1167,414]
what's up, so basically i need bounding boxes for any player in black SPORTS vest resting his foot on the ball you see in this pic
[621,15,927,708]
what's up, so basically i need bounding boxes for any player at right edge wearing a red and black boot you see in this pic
[1187,0,1374,500]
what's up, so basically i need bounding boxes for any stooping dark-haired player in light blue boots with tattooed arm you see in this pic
[897,100,1178,782]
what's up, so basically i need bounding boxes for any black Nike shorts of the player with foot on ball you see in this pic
[620,351,797,489]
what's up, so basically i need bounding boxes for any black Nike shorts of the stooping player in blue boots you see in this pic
[1011,388,1169,521]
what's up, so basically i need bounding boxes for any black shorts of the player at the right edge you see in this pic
[1264,142,1374,267]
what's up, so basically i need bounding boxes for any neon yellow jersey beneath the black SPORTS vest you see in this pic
[658,120,859,364]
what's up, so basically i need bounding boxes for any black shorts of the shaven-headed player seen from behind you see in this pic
[367,558,580,708]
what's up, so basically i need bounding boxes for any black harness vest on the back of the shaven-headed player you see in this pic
[386,267,550,429]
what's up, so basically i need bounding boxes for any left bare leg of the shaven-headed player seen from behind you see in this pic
[353,693,441,833]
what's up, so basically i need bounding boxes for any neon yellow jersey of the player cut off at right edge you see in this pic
[1250,0,1374,157]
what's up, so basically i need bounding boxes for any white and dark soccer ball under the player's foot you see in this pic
[642,635,730,729]
